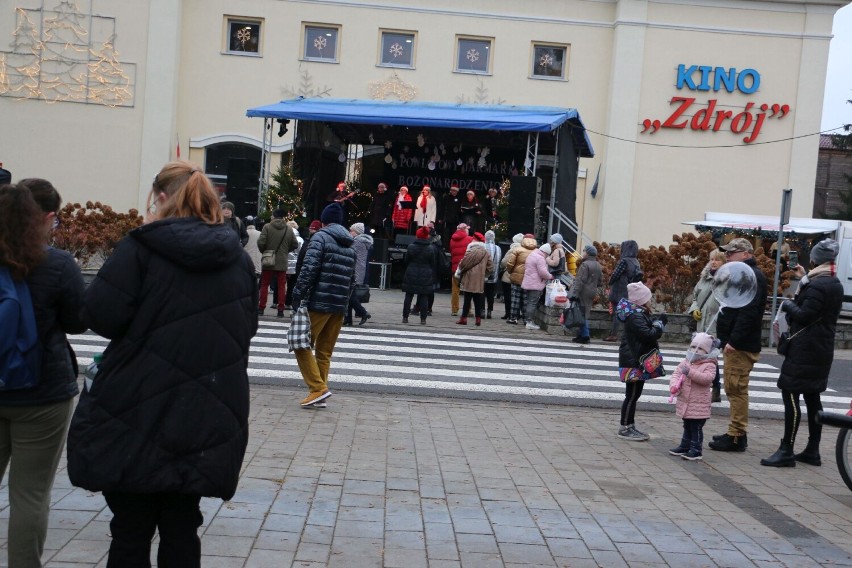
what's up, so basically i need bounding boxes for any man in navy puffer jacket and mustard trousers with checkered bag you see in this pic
[293,203,355,408]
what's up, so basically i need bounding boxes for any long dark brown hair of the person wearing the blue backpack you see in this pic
[0,185,46,280]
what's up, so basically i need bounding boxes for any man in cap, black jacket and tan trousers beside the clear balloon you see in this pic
[709,238,767,452]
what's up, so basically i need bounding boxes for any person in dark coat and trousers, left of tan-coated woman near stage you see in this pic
[402,227,443,325]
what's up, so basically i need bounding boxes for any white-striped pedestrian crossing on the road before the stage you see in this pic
[71,321,849,416]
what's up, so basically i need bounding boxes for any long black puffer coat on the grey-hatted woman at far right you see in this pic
[778,275,843,393]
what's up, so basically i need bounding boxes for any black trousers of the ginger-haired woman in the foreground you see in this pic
[104,492,204,568]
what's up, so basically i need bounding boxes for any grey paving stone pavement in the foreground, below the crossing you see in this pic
[0,386,852,568]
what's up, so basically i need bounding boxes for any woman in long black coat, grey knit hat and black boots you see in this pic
[760,239,843,467]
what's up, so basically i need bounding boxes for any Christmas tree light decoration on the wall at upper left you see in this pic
[0,0,136,107]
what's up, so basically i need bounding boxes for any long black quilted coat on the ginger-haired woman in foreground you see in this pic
[68,218,258,499]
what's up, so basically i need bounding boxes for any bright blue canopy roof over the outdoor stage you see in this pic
[246,97,594,158]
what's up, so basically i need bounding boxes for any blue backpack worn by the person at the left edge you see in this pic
[0,266,41,391]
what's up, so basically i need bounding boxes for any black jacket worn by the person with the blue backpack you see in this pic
[0,247,86,406]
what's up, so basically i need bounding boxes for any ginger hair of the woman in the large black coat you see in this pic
[151,161,224,225]
